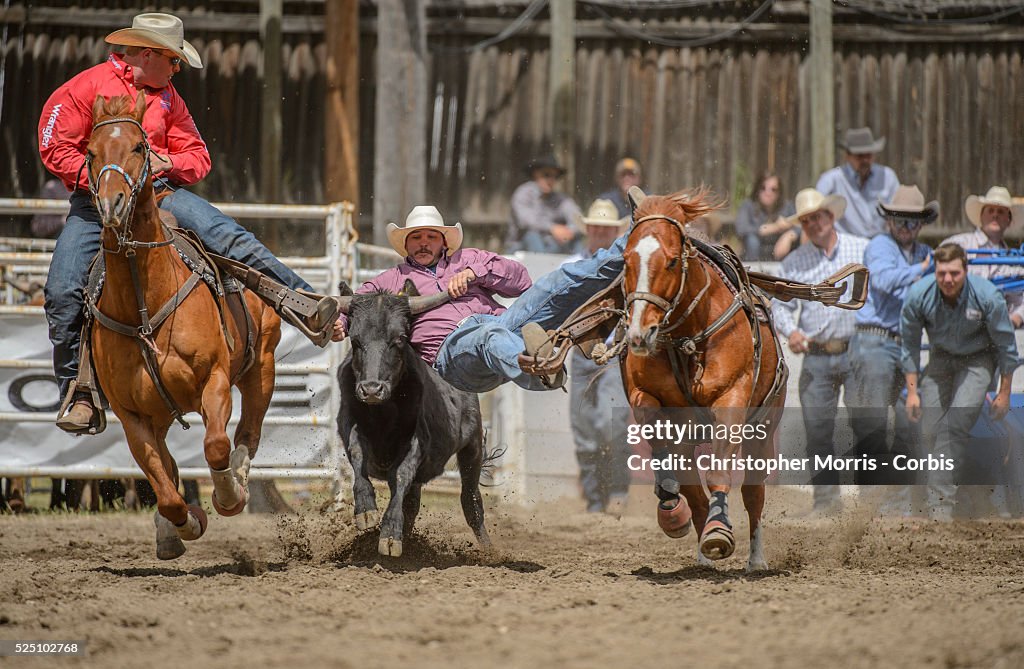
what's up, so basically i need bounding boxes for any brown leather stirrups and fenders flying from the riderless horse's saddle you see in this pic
[519,238,868,376]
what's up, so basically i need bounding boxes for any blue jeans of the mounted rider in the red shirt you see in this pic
[44,190,311,398]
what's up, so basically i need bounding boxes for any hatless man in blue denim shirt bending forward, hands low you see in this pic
[900,244,1020,521]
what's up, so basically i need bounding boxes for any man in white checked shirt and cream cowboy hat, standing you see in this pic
[772,189,867,515]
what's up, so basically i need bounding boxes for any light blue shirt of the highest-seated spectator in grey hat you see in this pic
[815,163,899,239]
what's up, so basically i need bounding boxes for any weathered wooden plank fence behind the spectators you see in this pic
[0,3,1024,247]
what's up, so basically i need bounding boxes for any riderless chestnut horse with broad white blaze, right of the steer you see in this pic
[623,189,788,571]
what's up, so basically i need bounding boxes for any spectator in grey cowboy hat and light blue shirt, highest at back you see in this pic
[816,128,899,239]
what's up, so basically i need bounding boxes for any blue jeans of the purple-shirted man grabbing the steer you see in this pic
[434,234,629,392]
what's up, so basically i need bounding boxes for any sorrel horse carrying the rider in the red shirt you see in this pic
[83,92,281,559]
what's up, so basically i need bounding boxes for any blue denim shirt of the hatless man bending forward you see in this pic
[900,275,1020,374]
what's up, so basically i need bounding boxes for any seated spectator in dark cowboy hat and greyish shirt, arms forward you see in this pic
[505,156,584,254]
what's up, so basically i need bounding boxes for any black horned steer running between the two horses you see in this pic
[338,281,490,557]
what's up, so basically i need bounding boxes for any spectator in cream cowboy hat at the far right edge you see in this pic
[943,185,1024,328]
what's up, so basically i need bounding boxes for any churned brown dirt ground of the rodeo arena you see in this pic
[0,487,1024,669]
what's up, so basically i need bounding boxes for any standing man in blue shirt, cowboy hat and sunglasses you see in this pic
[847,185,939,493]
